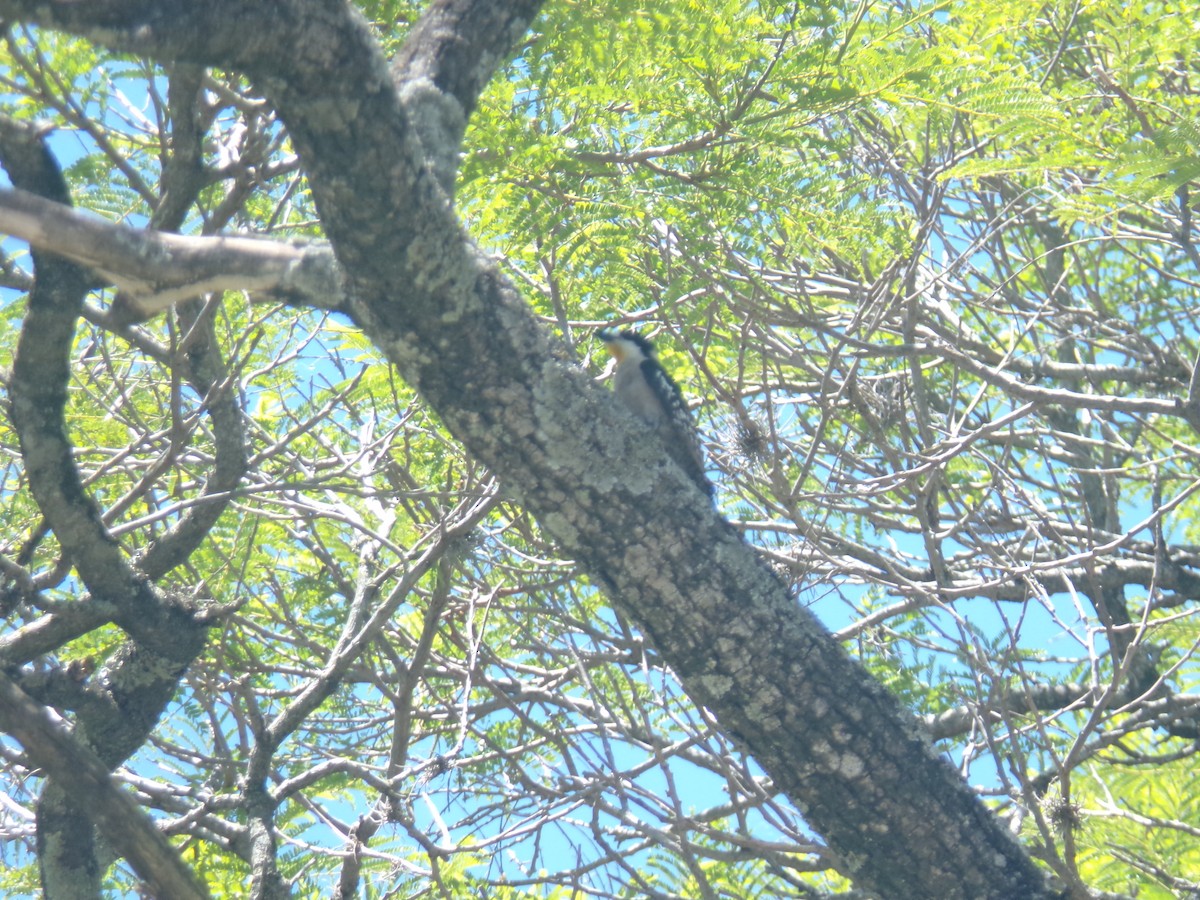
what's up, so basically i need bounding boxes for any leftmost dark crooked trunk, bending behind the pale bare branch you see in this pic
[0,109,206,895]
